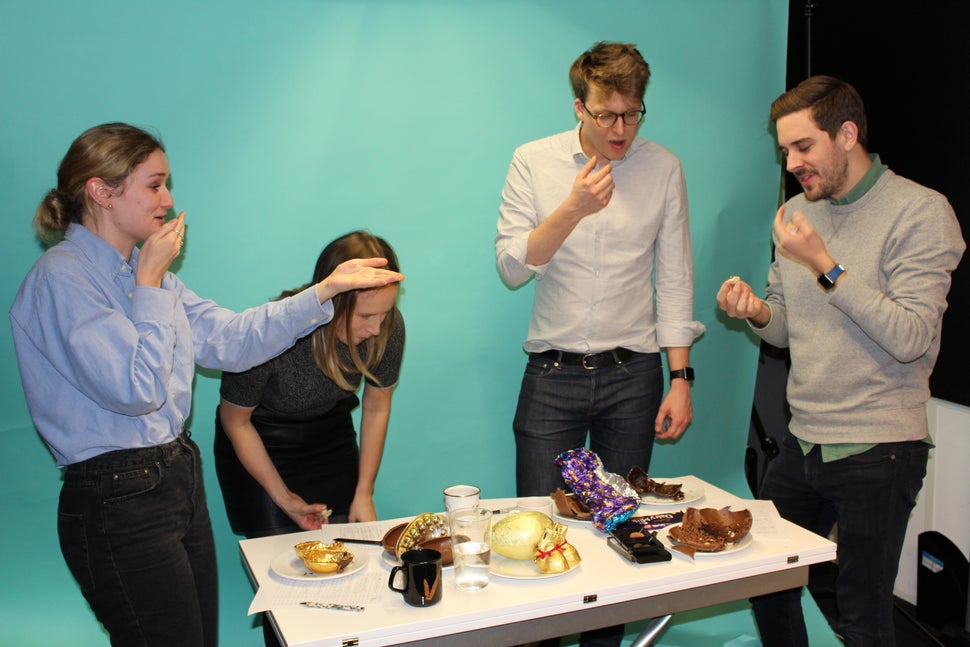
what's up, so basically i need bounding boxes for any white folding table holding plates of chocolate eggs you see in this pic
[239,476,835,647]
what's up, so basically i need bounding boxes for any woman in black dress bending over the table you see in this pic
[215,231,404,538]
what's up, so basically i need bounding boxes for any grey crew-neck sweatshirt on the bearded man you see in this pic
[753,170,966,443]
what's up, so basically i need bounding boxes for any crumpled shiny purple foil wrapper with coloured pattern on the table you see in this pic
[556,447,640,532]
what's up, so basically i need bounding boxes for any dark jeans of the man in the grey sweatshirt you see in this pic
[751,435,930,647]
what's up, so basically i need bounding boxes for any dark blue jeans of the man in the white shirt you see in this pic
[512,353,663,647]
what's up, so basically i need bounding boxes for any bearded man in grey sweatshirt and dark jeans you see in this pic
[717,76,965,647]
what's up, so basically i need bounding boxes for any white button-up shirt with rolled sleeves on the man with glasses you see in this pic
[495,124,704,353]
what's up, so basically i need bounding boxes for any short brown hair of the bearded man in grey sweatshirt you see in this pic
[771,75,869,148]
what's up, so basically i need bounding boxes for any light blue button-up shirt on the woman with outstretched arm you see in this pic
[10,224,333,467]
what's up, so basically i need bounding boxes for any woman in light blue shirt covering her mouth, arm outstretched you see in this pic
[10,123,403,646]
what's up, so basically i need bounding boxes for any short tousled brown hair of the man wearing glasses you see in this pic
[569,41,650,102]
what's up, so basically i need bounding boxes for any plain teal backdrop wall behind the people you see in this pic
[0,0,787,645]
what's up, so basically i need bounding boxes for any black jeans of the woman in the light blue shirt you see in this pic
[57,432,218,647]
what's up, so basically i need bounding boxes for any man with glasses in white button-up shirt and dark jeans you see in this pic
[495,43,704,644]
